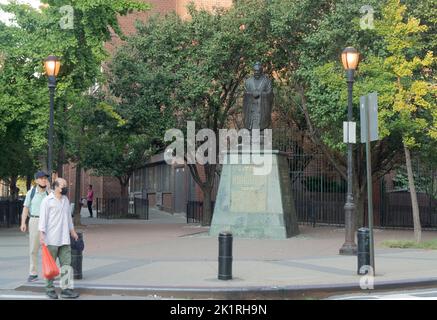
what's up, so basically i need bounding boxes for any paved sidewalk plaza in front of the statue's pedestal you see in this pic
[0,212,437,298]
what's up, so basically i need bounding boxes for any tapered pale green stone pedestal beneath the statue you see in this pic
[210,150,299,239]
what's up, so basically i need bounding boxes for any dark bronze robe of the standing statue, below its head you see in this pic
[243,75,273,130]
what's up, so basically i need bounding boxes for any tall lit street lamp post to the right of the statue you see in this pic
[340,47,360,255]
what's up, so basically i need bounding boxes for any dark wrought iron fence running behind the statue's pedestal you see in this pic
[187,169,437,229]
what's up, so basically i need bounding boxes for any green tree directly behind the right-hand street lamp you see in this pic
[270,0,436,226]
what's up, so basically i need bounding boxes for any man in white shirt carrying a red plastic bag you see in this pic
[38,178,79,299]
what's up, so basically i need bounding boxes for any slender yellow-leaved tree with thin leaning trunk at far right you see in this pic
[376,0,437,242]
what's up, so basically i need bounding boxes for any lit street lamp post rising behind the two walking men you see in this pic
[44,56,61,183]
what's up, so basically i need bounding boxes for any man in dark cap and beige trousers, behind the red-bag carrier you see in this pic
[20,171,49,282]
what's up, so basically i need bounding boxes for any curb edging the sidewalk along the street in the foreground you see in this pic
[15,277,437,300]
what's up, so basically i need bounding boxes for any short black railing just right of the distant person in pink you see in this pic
[96,198,149,220]
